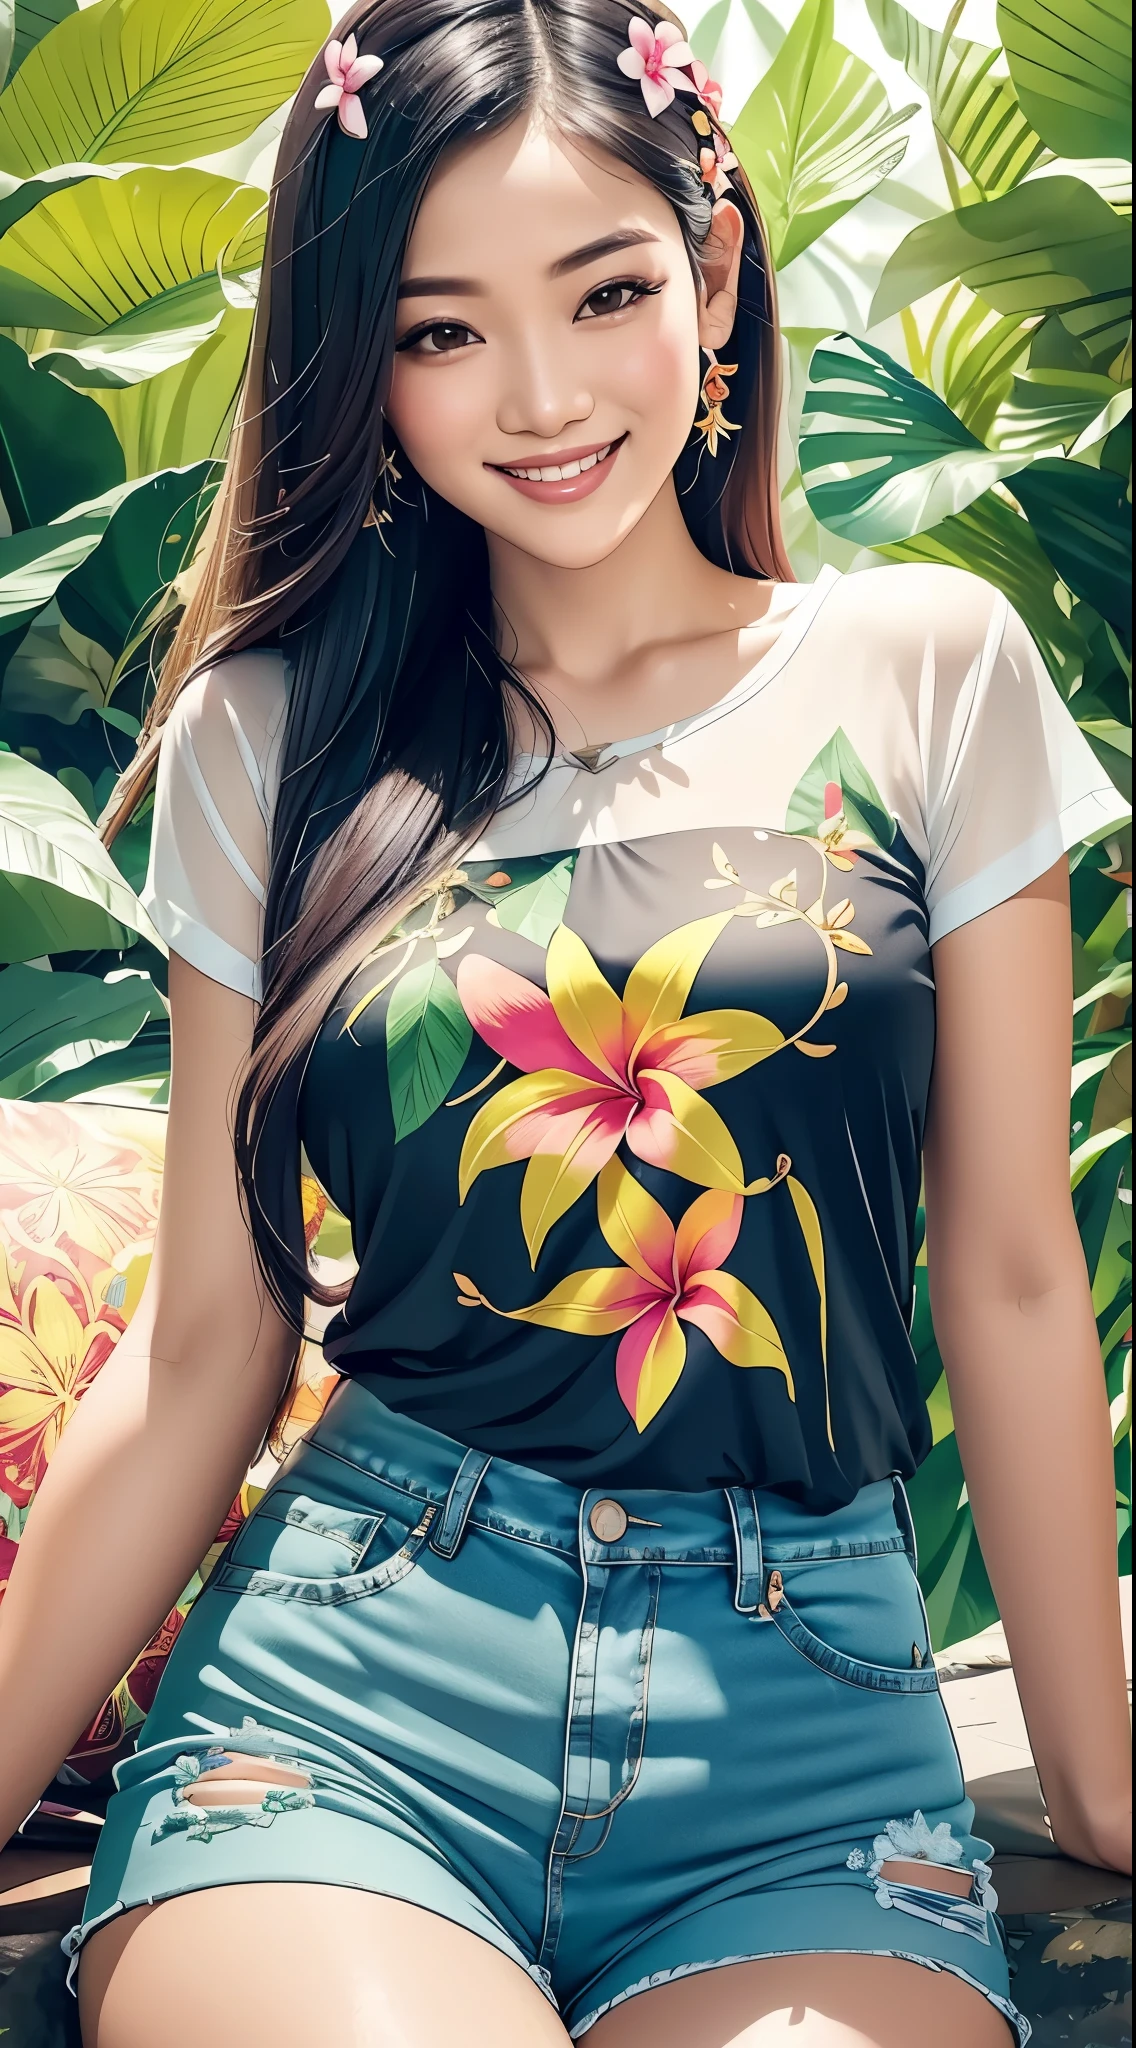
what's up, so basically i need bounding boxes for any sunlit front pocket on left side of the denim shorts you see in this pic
[209,1487,436,1608]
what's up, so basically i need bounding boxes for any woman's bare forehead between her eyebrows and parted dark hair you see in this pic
[407,117,682,276]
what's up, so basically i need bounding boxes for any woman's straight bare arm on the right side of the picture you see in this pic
[923,858,1132,1870]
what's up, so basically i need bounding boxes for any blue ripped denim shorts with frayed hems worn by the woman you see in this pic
[63,1380,1030,2044]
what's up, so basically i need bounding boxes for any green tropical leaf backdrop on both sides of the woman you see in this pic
[0,0,1132,1647]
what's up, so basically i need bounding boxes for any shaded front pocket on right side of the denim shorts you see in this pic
[772,1550,940,1692]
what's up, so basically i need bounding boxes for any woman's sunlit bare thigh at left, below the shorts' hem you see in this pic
[78,1884,567,2048]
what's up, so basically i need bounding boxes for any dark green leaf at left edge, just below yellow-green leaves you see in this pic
[0,336,127,528]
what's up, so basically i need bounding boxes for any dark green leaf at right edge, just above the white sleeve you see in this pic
[1011,459,1132,633]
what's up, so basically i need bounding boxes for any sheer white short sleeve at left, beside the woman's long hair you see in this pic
[141,649,285,1001]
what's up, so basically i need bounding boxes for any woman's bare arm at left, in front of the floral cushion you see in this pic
[0,956,297,1843]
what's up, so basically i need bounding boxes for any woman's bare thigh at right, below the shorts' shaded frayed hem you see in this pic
[585,1954,1013,2048]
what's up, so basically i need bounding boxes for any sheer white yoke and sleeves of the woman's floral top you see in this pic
[143,563,1130,997]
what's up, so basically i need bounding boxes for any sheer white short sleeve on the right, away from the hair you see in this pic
[919,569,1130,944]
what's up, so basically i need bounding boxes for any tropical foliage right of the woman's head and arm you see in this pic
[704,0,1132,1645]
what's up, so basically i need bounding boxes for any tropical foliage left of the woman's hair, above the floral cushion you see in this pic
[0,0,330,1102]
